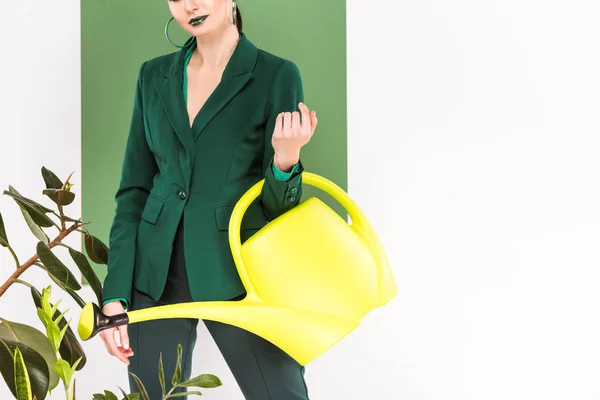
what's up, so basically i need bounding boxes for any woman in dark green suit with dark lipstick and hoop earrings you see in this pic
[100,0,317,400]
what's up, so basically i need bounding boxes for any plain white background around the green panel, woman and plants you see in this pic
[0,0,600,400]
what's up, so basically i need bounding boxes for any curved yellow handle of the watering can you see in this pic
[229,172,387,304]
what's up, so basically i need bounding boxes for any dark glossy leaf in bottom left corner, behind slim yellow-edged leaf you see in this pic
[0,339,49,400]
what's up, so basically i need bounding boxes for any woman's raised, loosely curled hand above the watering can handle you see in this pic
[271,103,318,172]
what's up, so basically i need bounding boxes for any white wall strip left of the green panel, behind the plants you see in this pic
[0,0,83,399]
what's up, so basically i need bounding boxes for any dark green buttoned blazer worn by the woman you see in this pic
[103,33,304,306]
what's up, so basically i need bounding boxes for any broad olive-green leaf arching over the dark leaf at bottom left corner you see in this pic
[0,320,59,390]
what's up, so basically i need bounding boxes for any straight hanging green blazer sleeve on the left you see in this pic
[102,63,158,307]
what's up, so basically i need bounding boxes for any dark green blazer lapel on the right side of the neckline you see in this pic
[192,32,258,141]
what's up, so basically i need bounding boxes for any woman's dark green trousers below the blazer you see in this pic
[128,220,308,400]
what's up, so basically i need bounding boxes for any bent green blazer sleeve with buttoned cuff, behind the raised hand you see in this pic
[260,60,304,220]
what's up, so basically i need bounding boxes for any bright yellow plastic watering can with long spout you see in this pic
[78,172,397,365]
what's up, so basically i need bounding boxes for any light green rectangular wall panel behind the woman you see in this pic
[81,0,347,279]
